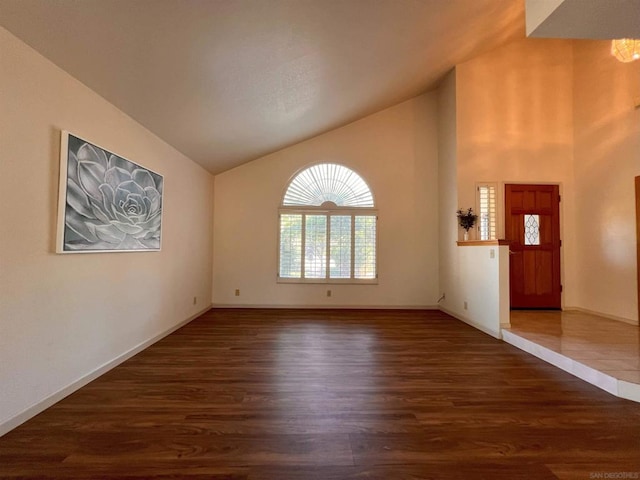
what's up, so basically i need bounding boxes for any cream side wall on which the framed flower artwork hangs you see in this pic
[0,28,213,434]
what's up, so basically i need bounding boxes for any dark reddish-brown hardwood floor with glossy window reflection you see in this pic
[0,310,640,480]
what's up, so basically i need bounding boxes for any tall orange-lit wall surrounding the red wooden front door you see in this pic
[456,39,578,305]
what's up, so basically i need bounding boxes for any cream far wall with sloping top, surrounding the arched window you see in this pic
[213,93,438,307]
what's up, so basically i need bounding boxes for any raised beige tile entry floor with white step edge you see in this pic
[502,310,640,402]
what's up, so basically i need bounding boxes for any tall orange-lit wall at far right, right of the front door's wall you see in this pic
[573,41,640,323]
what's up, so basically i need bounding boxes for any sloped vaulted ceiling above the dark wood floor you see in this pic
[0,0,525,173]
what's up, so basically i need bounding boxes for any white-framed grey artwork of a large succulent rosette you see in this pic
[56,131,164,253]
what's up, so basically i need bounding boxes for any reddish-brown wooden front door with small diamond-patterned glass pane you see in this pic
[505,185,562,309]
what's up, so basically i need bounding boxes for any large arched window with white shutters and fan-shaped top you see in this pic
[278,163,378,283]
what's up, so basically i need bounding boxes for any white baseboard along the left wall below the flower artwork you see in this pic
[0,305,211,437]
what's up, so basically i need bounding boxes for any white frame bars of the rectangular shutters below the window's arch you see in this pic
[276,205,379,284]
